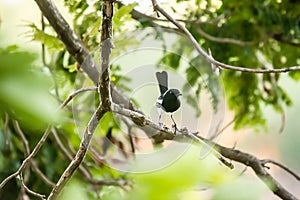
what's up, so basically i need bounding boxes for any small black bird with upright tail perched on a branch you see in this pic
[155,71,182,134]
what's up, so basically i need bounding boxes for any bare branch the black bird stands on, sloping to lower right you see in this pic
[112,105,297,200]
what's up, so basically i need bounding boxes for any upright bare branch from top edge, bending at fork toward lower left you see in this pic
[48,0,113,200]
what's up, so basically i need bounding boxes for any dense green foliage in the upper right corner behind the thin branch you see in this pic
[156,0,300,128]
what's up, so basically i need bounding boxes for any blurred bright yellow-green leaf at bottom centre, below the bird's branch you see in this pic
[127,147,231,200]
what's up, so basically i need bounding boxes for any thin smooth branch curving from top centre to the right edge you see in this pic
[152,0,300,73]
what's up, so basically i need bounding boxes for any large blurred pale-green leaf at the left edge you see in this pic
[0,47,60,128]
